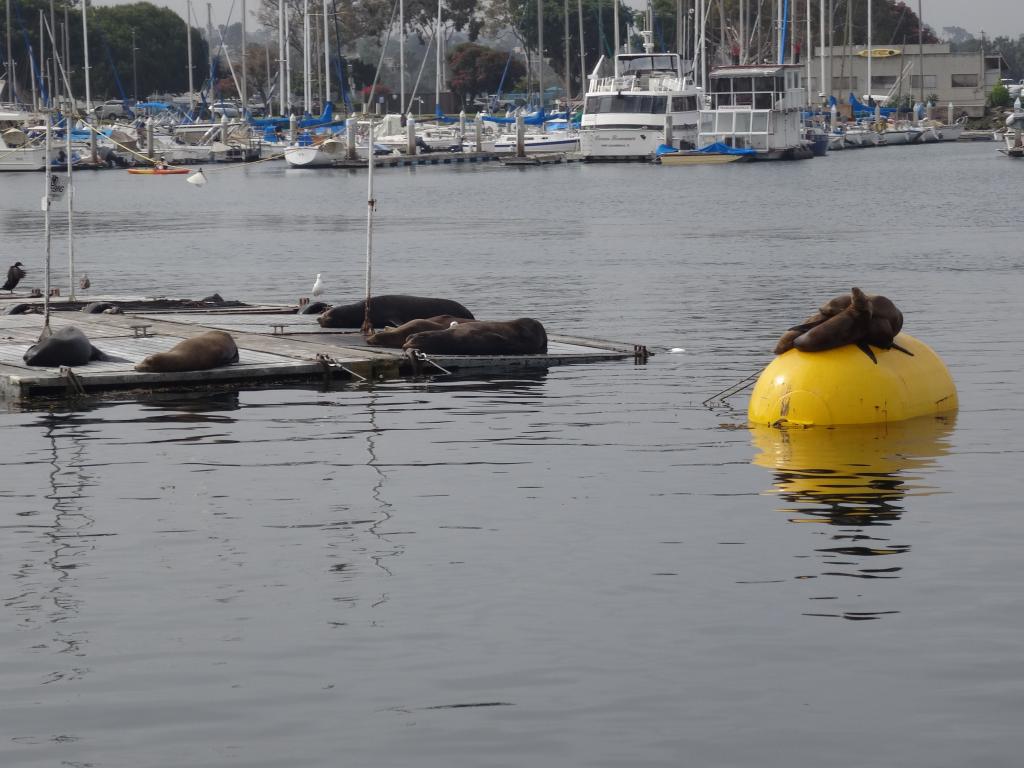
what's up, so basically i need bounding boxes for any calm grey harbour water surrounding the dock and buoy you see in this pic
[0,144,1024,768]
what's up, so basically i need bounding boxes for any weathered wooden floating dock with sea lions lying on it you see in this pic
[0,299,647,401]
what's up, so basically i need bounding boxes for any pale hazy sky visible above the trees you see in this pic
[95,0,1024,38]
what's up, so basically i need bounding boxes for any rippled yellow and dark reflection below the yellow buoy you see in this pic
[751,416,955,620]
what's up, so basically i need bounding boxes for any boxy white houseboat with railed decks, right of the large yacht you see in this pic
[697,65,815,160]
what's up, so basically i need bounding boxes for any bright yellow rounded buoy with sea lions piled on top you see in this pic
[748,334,958,426]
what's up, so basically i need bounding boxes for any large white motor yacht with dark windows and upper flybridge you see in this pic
[580,32,703,160]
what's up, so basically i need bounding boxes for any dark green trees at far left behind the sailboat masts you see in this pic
[0,0,207,102]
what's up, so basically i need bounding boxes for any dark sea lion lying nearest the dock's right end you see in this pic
[402,317,548,354]
